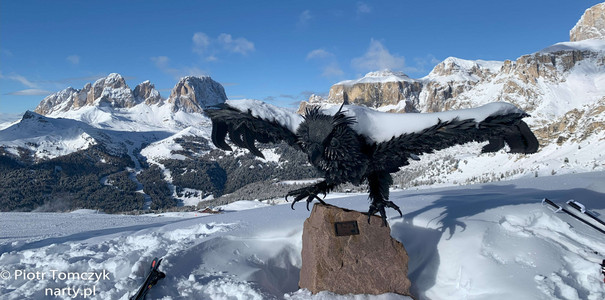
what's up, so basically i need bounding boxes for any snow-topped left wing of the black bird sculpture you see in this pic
[205,100,303,158]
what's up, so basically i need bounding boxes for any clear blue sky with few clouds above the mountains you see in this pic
[0,0,601,114]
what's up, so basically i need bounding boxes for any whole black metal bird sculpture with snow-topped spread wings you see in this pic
[206,100,538,225]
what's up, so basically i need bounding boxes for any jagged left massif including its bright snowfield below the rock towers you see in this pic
[35,73,227,132]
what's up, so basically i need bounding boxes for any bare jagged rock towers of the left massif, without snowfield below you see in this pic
[35,73,227,115]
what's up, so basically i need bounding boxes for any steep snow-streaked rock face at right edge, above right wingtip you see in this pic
[438,41,605,119]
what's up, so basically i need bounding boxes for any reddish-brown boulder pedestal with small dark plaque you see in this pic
[299,204,411,296]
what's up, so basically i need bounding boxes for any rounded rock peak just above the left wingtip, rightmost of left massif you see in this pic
[168,76,227,113]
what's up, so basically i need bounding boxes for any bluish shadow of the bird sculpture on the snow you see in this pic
[384,175,605,299]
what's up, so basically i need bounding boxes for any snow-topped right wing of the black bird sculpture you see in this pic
[326,102,538,172]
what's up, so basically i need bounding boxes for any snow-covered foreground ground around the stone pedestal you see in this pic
[0,172,605,300]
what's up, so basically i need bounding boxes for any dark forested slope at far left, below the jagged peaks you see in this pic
[0,146,144,213]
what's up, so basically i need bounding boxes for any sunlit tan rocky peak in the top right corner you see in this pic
[569,2,605,42]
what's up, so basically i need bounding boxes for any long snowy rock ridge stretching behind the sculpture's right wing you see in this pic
[298,40,605,118]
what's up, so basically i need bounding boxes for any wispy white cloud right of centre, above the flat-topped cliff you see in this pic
[351,39,405,71]
